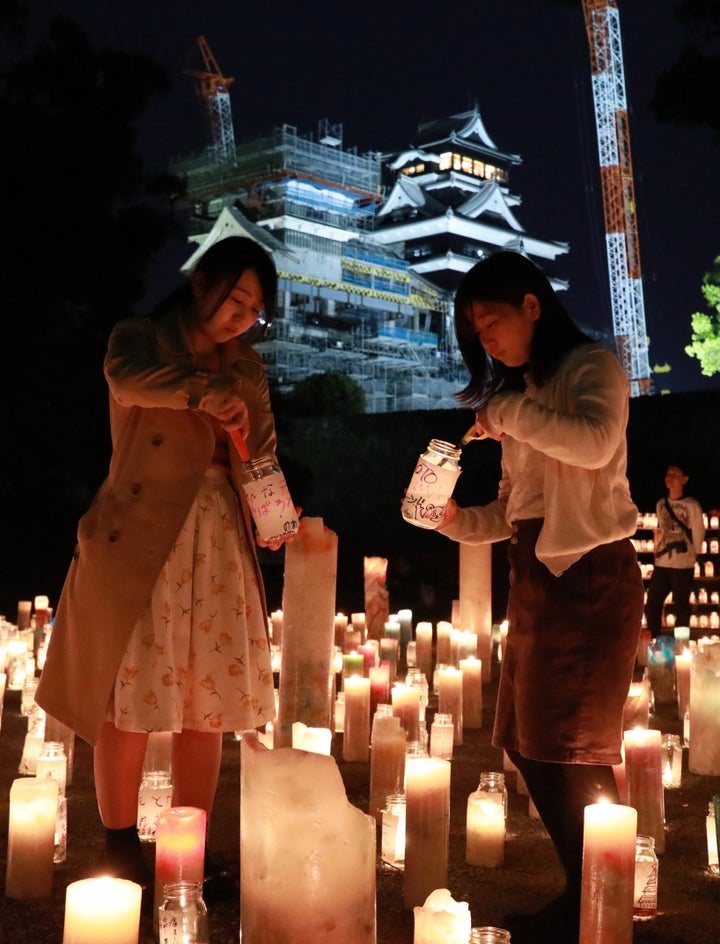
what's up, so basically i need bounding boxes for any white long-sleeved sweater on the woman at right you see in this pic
[442,344,638,575]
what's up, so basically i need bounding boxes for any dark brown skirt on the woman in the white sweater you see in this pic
[493,519,643,764]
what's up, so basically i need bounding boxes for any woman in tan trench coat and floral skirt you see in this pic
[37,237,296,884]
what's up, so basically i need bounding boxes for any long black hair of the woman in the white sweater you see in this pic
[454,250,592,407]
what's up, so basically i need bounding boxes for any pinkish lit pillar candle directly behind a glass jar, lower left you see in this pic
[155,808,205,914]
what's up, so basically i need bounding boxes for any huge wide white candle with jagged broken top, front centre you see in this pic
[240,733,377,944]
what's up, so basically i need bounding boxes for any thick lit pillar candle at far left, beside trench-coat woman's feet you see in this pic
[5,777,58,898]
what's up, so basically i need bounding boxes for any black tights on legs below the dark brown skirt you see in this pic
[507,750,618,907]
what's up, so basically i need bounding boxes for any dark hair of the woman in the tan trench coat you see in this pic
[150,236,277,336]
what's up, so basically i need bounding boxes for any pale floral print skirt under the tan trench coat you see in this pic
[108,469,275,732]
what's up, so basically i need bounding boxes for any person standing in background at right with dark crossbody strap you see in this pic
[645,465,705,639]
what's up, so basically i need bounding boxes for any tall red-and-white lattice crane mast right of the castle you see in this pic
[583,0,652,396]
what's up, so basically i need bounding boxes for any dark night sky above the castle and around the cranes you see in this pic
[31,0,720,392]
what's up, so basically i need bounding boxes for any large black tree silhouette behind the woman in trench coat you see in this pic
[0,7,184,600]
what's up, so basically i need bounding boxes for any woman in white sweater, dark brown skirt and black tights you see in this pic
[438,251,643,944]
